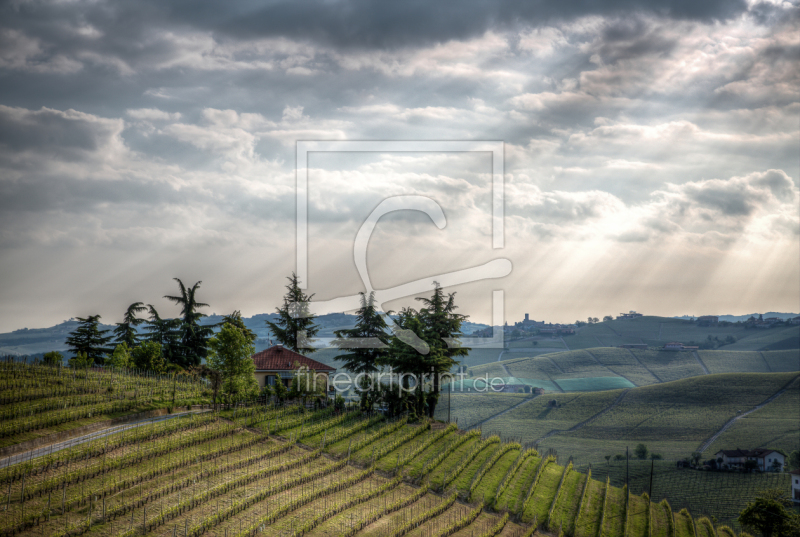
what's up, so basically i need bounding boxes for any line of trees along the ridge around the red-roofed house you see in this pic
[56,273,470,416]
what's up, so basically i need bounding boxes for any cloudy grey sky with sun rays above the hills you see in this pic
[0,0,800,331]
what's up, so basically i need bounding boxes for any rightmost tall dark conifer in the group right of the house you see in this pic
[417,282,470,418]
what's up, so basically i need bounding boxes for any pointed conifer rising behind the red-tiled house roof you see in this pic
[267,272,319,354]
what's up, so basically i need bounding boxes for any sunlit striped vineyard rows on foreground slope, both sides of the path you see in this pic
[0,364,756,537]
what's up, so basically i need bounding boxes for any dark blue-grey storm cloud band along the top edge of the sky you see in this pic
[0,0,747,55]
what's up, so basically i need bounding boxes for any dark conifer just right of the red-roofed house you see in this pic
[333,293,391,409]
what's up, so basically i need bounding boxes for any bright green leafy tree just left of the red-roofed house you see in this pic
[208,322,258,398]
